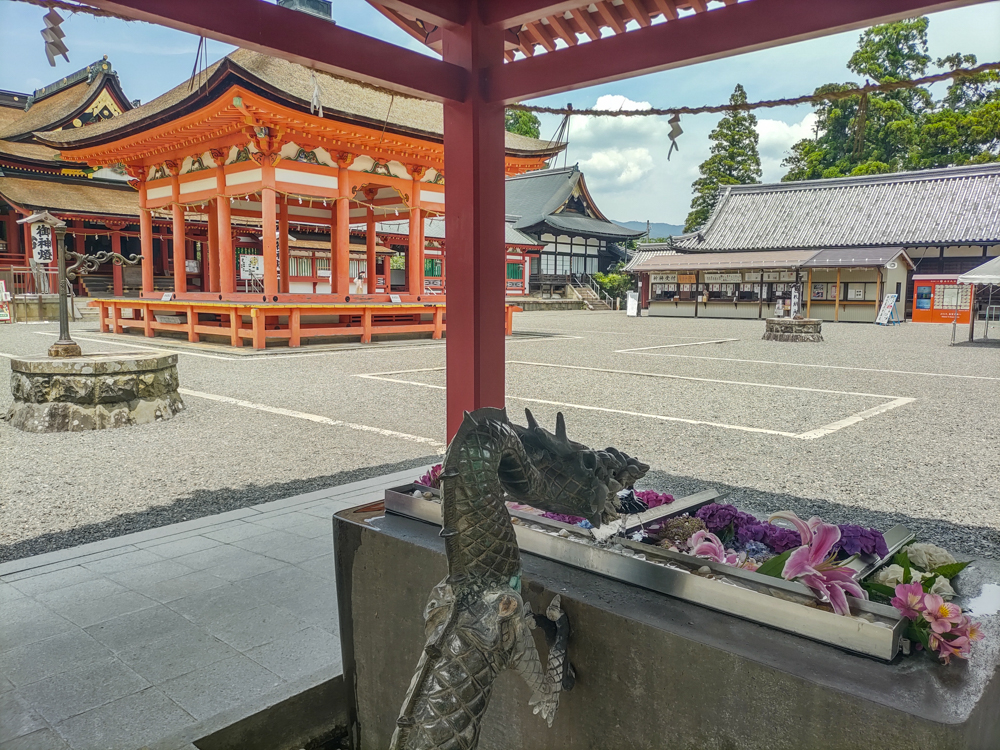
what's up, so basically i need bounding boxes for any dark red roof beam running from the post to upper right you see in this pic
[487,0,984,104]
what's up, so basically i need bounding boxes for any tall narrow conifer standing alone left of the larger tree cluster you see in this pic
[684,84,761,232]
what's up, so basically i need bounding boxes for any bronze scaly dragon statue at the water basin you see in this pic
[390,408,649,750]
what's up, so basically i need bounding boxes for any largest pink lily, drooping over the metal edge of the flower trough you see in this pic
[768,510,868,615]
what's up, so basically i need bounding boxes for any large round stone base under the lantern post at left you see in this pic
[7,352,184,432]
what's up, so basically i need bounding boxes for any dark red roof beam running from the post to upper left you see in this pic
[88,0,467,101]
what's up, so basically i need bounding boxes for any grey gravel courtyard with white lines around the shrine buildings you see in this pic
[0,312,1000,560]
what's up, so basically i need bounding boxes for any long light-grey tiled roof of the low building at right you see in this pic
[670,163,1000,252]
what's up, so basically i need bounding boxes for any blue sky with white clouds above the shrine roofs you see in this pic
[0,0,1000,224]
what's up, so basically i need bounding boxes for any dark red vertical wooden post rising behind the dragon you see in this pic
[443,12,506,439]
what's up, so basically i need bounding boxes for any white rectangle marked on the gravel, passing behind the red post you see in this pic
[355,368,916,440]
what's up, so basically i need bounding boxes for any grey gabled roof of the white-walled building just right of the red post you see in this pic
[505,165,645,241]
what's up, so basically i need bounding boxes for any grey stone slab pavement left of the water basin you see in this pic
[0,469,423,750]
